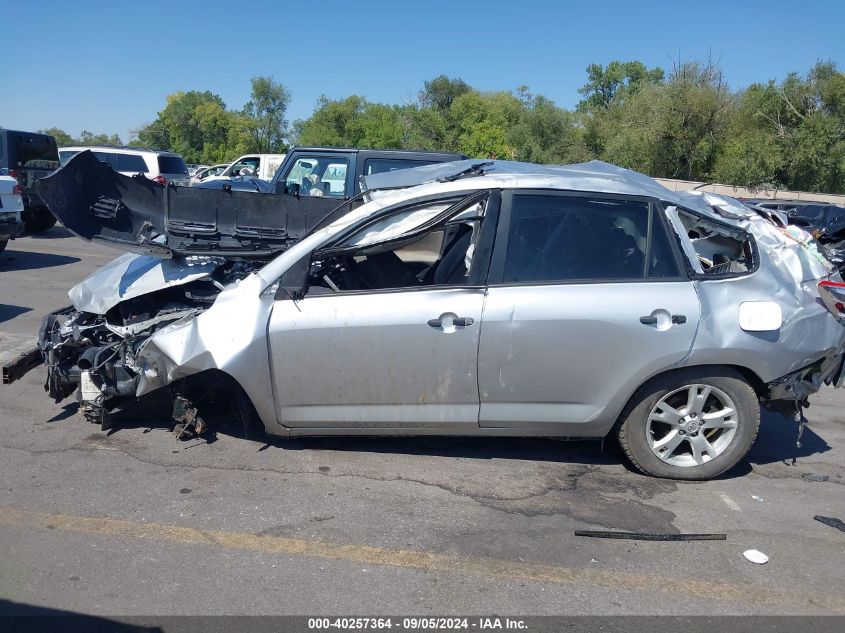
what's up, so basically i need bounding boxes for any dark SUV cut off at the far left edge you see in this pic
[0,129,59,233]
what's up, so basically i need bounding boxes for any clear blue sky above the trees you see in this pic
[0,0,845,141]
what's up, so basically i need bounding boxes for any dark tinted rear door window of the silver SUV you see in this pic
[502,194,680,283]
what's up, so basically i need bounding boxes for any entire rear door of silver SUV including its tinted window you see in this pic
[478,191,699,436]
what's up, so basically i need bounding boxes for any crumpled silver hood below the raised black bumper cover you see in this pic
[68,253,219,314]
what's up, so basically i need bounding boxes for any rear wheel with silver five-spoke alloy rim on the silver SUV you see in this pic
[618,367,760,480]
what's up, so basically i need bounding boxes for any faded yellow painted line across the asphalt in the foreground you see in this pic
[0,507,845,611]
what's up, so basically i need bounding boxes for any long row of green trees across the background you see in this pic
[39,61,845,193]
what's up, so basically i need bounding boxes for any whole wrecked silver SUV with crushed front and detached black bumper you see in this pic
[6,154,845,479]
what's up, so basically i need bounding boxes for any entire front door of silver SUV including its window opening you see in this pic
[268,192,498,432]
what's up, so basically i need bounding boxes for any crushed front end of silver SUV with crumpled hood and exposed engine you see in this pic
[38,255,258,426]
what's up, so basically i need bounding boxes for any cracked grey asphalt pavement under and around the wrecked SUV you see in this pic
[0,227,845,615]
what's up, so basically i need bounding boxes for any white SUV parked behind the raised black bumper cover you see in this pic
[59,145,191,187]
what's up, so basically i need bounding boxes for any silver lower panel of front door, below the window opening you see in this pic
[268,288,484,429]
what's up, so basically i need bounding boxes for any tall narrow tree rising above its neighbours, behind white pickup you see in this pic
[243,77,290,154]
